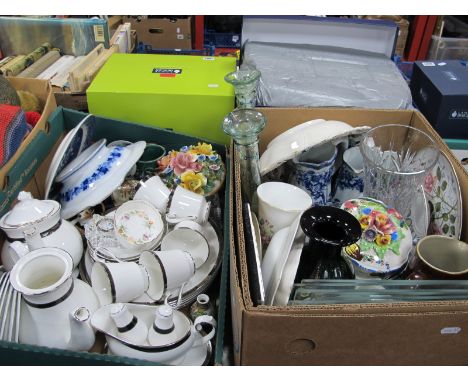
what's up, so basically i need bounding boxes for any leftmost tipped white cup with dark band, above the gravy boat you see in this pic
[91,262,149,305]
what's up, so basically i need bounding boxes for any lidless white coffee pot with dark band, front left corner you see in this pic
[10,248,99,351]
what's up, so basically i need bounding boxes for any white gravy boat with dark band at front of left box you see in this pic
[91,303,216,365]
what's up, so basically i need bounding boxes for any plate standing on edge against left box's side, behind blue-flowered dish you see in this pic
[44,114,94,199]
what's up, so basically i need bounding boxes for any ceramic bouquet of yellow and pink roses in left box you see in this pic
[157,143,226,196]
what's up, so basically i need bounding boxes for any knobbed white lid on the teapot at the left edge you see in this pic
[0,191,60,229]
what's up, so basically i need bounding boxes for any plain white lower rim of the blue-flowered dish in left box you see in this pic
[61,141,146,219]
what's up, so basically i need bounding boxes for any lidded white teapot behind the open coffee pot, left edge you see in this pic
[0,191,83,271]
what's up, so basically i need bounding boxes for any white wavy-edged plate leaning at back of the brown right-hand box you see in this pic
[260,121,370,176]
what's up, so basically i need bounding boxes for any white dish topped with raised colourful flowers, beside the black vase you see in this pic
[341,198,413,278]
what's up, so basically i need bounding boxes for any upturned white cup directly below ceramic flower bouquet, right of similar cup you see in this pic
[166,186,210,224]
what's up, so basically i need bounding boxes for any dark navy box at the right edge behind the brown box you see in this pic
[410,60,468,139]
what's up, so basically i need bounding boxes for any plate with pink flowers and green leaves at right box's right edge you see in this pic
[424,151,463,239]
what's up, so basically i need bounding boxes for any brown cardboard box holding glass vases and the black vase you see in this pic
[230,108,468,365]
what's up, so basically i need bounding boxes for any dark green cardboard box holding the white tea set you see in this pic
[0,107,231,366]
